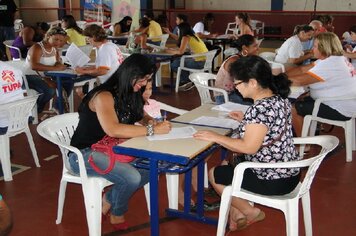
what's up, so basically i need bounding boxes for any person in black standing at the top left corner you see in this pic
[0,0,17,61]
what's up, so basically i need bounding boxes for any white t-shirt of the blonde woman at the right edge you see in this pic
[307,56,356,117]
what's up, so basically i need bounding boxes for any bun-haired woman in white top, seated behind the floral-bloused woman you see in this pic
[275,25,314,67]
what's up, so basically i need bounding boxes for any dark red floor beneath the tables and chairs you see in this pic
[0,70,356,236]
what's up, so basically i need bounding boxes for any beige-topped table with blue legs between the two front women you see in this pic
[114,104,231,236]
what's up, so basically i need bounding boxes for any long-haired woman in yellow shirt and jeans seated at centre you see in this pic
[166,23,208,91]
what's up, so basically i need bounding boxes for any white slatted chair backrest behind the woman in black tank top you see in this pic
[37,113,79,177]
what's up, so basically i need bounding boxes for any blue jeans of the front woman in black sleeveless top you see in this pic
[69,148,149,216]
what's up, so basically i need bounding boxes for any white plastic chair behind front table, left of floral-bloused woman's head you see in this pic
[189,72,229,105]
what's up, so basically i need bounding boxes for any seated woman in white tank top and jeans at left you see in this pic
[26,27,69,113]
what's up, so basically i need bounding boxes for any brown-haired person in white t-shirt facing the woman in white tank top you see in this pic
[75,25,124,93]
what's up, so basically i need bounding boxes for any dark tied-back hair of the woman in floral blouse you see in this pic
[229,56,292,98]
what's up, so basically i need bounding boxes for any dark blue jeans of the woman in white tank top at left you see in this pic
[26,75,56,113]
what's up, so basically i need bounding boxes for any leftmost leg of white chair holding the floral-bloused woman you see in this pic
[216,186,232,236]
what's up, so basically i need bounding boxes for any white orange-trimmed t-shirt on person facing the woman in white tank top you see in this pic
[95,42,124,83]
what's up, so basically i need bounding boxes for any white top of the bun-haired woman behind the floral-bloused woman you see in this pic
[274,35,304,64]
